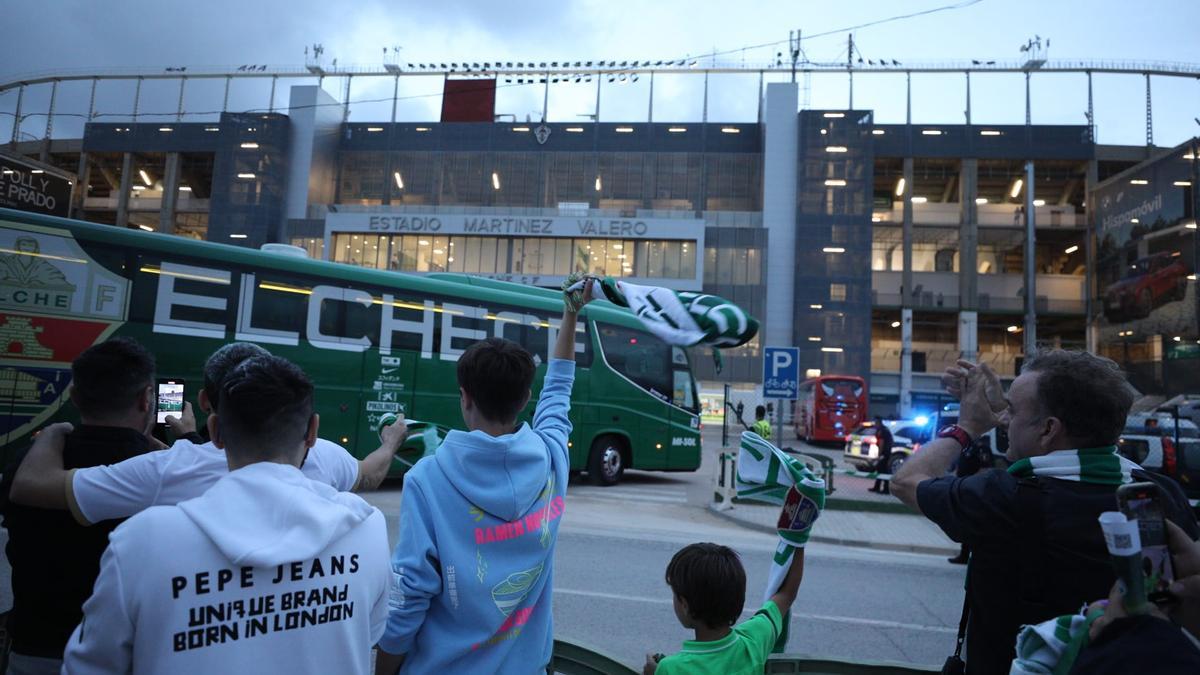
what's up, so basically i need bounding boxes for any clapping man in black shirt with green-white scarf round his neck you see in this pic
[893,351,1200,674]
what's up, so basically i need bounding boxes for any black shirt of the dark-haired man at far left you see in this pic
[0,425,150,658]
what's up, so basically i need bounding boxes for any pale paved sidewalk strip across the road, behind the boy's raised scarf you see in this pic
[710,497,959,556]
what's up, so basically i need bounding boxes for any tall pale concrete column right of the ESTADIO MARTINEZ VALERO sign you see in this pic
[762,82,800,346]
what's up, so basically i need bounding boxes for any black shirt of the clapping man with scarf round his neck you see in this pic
[917,470,1200,674]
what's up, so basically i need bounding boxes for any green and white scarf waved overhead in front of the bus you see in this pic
[563,275,758,372]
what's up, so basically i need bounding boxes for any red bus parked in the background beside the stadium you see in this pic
[793,375,866,443]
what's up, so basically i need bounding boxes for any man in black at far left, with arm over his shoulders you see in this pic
[0,338,155,673]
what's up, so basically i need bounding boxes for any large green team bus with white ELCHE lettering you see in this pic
[0,209,701,484]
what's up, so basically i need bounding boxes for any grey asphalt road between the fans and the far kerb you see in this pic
[366,420,964,669]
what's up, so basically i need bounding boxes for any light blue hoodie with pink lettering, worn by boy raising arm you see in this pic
[379,359,575,675]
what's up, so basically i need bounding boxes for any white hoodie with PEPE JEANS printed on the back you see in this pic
[62,462,391,675]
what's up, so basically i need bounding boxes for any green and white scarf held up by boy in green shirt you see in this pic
[734,431,826,653]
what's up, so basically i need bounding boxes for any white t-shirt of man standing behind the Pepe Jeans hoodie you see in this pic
[71,438,359,522]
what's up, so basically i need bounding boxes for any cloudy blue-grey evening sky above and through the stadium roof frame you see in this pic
[0,0,1200,145]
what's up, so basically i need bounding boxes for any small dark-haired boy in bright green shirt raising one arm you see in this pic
[642,543,804,675]
